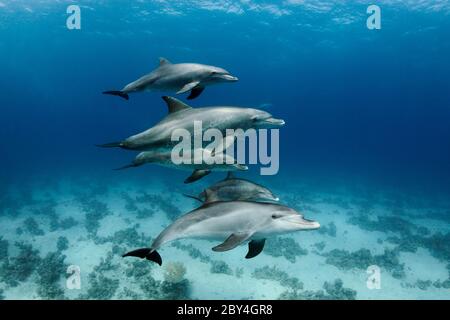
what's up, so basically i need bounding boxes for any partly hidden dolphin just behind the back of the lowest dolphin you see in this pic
[185,171,279,203]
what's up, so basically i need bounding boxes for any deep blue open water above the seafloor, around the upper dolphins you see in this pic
[0,0,450,298]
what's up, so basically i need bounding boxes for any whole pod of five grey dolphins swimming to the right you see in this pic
[98,58,320,265]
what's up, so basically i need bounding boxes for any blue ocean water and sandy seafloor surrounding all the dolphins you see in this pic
[0,0,450,299]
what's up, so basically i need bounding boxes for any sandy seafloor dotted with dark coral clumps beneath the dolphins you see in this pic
[0,175,450,299]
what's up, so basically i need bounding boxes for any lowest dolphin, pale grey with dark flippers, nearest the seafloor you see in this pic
[123,201,320,265]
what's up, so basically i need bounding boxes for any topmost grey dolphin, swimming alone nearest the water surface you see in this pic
[103,58,238,100]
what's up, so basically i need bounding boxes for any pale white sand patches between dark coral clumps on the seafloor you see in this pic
[0,181,450,299]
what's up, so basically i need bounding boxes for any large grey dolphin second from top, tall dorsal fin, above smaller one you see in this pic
[98,96,284,151]
